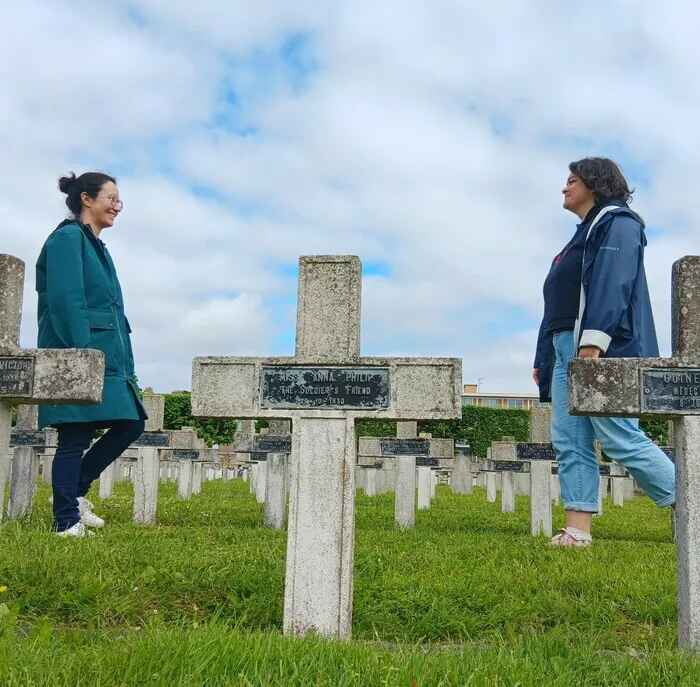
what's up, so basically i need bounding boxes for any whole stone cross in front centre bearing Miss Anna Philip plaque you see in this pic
[192,256,462,637]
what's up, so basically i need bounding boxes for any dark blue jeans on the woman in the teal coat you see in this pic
[52,420,146,532]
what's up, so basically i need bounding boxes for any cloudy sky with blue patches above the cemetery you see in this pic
[0,0,700,392]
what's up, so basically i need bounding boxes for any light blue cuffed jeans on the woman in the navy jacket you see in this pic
[552,331,676,513]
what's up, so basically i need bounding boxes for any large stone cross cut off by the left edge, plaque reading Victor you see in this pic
[0,255,104,486]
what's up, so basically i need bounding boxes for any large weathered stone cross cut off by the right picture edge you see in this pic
[569,256,700,650]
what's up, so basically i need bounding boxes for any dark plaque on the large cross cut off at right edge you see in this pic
[642,368,700,415]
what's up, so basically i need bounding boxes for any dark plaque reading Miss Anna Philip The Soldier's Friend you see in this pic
[260,367,389,410]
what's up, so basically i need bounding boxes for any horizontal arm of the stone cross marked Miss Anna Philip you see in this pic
[192,357,462,420]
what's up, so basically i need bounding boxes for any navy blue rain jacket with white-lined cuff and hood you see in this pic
[534,201,659,403]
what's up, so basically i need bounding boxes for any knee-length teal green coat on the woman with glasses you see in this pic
[36,221,147,428]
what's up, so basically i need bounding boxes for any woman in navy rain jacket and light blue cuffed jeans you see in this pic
[533,158,675,546]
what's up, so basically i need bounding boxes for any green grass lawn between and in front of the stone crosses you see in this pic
[0,479,700,687]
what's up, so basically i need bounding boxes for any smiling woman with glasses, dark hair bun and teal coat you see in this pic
[36,172,147,537]
